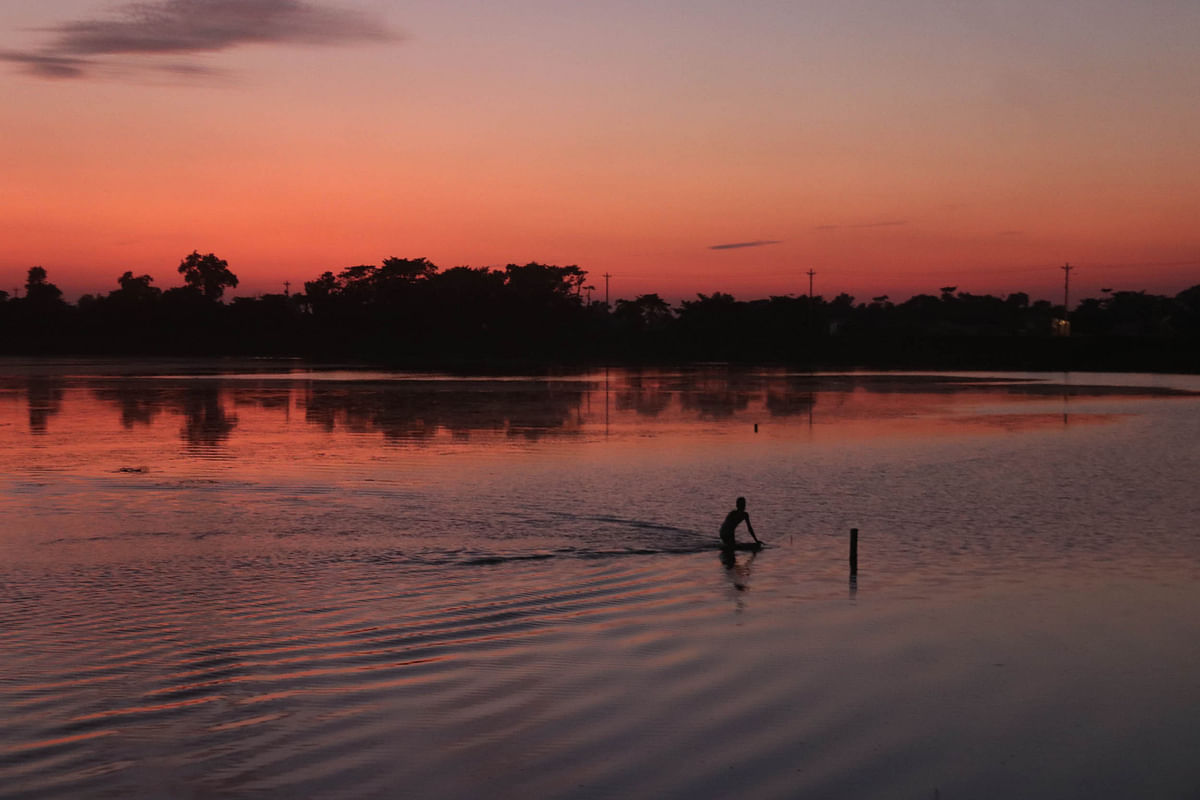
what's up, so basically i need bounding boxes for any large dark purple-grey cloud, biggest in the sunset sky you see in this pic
[0,0,398,79]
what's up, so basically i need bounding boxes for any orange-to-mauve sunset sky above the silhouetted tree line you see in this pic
[0,0,1200,300]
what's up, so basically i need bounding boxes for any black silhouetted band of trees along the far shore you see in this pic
[0,252,1200,373]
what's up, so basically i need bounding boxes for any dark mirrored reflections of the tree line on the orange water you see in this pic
[51,368,835,450]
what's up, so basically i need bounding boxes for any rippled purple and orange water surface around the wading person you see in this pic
[0,361,1200,798]
